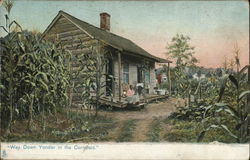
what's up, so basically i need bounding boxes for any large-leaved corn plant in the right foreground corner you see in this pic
[197,66,250,143]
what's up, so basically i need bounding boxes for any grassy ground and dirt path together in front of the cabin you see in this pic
[0,98,183,142]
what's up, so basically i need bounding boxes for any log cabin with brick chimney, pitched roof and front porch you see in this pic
[42,11,171,106]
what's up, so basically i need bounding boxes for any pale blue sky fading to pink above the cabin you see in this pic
[0,0,249,68]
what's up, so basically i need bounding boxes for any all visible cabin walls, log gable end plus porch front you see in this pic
[44,16,156,106]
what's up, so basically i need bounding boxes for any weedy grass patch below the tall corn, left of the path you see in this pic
[0,112,116,142]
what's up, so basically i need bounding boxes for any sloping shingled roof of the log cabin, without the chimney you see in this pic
[43,11,171,63]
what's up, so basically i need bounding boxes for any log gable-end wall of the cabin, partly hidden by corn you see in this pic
[44,16,103,106]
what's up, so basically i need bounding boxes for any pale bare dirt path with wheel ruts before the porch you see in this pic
[99,98,182,142]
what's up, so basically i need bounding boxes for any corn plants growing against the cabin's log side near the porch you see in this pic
[72,40,113,116]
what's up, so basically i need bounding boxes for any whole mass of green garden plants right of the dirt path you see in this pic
[166,50,250,143]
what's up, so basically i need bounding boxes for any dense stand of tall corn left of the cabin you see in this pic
[0,31,70,131]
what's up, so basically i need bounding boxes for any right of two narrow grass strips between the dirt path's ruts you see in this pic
[146,119,161,142]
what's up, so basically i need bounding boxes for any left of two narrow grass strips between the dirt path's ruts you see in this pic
[116,119,137,142]
